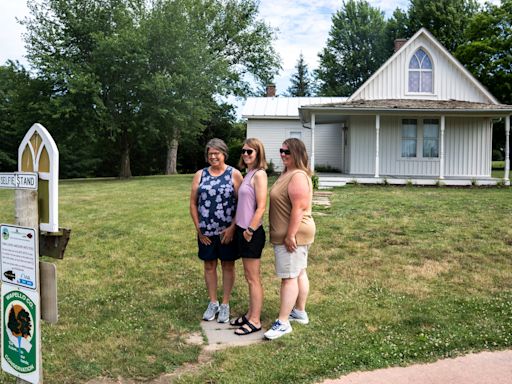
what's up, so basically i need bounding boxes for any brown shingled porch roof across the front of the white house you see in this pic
[299,99,512,124]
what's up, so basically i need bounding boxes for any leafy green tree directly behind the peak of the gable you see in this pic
[407,0,478,52]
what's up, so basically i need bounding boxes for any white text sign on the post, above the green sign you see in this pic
[0,224,37,290]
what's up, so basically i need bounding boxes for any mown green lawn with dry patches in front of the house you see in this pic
[0,175,512,384]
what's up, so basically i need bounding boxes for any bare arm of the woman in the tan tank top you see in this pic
[284,172,310,252]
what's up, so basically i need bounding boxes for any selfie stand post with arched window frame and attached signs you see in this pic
[0,124,70,384]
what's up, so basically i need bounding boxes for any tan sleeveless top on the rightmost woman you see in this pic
[269,169,316,245]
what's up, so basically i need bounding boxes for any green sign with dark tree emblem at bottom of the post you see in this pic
[3,290,37,373]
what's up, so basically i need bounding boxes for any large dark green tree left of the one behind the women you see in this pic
[24,0,148,177]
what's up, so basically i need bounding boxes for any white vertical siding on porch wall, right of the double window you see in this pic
[444,118,492,177]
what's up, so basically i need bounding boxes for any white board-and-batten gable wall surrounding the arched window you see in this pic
[348,28,498,104]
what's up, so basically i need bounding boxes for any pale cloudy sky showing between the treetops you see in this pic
[0,0,499,95]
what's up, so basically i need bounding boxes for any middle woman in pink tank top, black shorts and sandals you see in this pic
[231,138,267,336]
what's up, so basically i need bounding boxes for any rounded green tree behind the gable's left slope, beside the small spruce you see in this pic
[316,0,389,96]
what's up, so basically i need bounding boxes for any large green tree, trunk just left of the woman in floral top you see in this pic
[147,0,279,174]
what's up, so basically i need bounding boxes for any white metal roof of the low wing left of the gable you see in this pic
[242,97,347,119]
